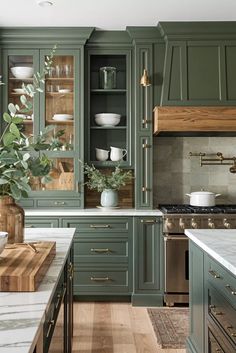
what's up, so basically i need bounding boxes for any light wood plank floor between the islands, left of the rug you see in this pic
[73,303,186,353]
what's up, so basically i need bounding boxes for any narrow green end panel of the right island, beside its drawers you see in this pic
[187,241,205,353]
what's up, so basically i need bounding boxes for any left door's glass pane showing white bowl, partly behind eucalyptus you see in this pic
[8,55,34,136]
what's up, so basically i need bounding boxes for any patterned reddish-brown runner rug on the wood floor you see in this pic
[147,308,189,348]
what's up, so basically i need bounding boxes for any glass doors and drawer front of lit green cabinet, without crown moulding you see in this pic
[3,49,83,207]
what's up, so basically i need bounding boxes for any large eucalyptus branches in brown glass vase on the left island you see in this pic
[0,47,60,243]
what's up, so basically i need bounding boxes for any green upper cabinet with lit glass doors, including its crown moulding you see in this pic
[0,28,93,208]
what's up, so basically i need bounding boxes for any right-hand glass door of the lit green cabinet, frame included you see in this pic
[35,50,81,201]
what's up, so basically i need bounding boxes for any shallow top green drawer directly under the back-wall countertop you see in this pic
[63,216,132,234]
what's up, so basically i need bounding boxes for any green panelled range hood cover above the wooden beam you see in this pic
[158,22,236,106]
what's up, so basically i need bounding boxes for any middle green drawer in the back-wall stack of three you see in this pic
[74,237,128,262]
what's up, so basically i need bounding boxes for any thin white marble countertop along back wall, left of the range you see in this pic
[25,208,163,217]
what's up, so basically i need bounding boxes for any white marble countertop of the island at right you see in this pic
[185,229,236,276]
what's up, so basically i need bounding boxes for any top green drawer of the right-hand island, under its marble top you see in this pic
[206,256,236,308]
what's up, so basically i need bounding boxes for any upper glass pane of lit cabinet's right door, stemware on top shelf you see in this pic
[45,55,75,151]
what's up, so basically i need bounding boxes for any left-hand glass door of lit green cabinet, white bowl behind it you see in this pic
[3,50,39,136]
